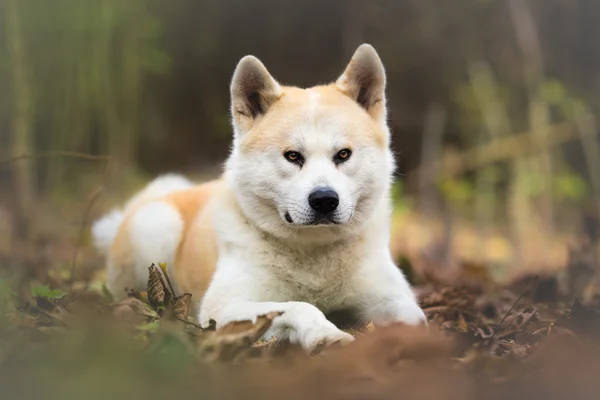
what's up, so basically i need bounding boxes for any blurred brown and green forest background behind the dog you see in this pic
[0,0,600,286]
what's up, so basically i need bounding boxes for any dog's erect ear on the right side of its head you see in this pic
[335,44,385,118]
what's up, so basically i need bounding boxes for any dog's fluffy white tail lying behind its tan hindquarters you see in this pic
[92,174,193,253]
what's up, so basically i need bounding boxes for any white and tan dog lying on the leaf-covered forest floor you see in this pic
[93,44,425,351]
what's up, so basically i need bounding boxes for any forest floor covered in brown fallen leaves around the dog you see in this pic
[0,203,600,400]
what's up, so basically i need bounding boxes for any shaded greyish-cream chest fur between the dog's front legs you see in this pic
[263,241,360,311]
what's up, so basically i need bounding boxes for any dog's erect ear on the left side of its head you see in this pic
[231,56,283,133]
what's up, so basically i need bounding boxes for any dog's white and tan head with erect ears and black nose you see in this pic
[226,44,394,242]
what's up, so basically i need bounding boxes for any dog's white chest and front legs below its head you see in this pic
[199,183,426,351]
